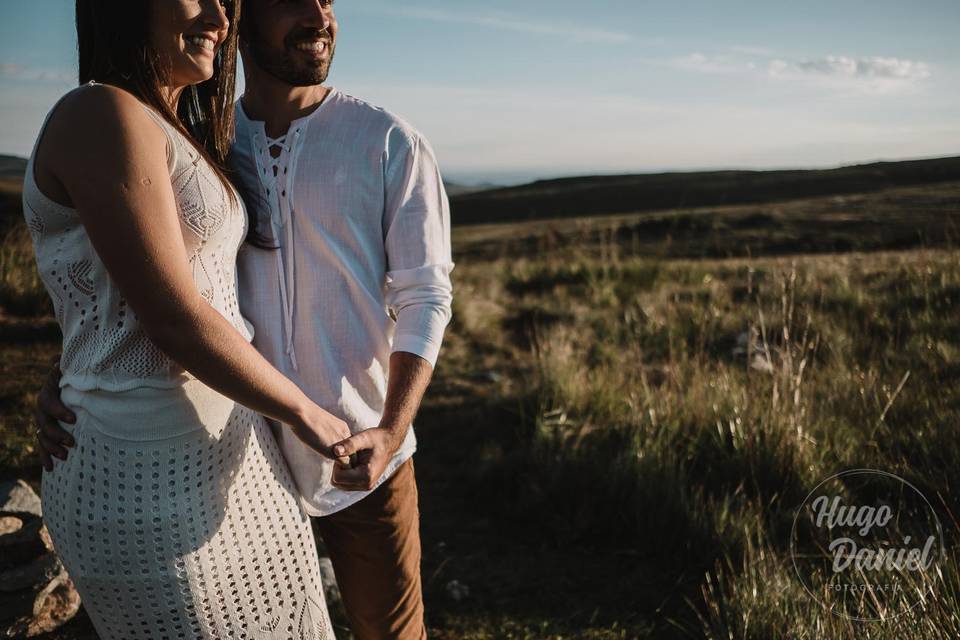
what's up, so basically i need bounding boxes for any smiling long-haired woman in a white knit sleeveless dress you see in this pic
[24,0,349,640]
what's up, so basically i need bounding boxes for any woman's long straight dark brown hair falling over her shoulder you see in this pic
[77,0,264,246]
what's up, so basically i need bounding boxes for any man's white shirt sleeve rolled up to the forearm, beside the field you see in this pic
[384,130,454,366]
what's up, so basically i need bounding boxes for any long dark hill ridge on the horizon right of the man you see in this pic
[451,157,960,224]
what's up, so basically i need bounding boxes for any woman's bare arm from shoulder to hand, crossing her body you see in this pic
[38,86,350,457]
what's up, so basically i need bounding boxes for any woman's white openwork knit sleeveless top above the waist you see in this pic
[23,83,253,391]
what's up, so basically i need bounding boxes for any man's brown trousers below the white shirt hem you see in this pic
[312,458,427,640]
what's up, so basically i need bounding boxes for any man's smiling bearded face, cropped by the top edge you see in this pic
[240,0,337,87]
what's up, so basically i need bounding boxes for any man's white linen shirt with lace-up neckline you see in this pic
[231,88,454,516]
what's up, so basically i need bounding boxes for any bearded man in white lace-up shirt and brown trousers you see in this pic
[37,0,453,639]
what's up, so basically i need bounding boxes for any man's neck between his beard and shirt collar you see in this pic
[240,74,330,138]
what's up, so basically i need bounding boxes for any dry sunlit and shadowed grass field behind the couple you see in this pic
[0,172,960,640]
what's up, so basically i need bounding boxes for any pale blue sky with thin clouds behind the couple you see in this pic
[0,0,960,184]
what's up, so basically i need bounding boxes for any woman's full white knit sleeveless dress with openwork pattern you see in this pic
[23,88,333,640]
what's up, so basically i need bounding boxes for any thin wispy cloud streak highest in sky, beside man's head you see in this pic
[352,5,635,44]
